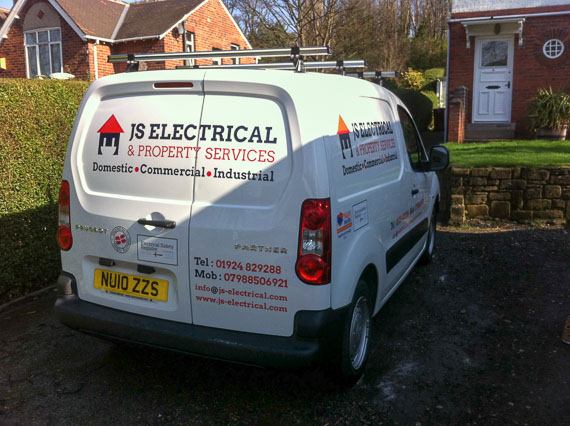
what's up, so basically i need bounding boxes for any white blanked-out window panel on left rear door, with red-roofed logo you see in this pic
[78,93,205,201]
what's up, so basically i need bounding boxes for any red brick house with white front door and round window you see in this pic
[447,0,570,142]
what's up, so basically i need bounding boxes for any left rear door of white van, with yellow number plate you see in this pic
[68,75,204,323]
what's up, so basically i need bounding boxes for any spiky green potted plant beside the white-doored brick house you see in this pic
[529,86,570,140]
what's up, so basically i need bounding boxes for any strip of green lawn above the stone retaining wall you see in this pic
[445,140,570,167]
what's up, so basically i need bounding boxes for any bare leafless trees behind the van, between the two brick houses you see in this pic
[222,0,452,70]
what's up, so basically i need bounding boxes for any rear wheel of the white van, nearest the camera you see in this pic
[337,280,372,386]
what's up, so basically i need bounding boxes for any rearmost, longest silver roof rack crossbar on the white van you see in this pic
[108,46,332,63]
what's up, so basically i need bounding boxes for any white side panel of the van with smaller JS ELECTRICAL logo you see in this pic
[325,97,410,308]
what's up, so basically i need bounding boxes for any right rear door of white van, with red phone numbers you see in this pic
[186,70,330,336]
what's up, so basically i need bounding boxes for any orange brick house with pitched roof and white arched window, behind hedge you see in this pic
[0,0,253,80]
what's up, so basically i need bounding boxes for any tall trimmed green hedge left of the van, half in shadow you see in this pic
[0,79,88,304]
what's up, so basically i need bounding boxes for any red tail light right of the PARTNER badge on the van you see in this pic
[295,198,331,284]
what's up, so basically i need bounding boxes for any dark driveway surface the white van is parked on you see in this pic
[0,225,570,425]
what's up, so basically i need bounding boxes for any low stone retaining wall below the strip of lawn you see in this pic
[442,166,570,224]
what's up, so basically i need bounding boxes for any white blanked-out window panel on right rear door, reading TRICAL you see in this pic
[195,94,291,206]
